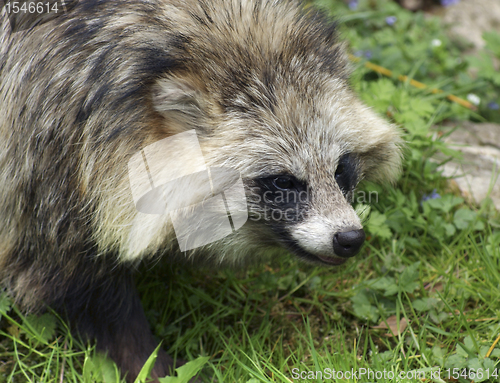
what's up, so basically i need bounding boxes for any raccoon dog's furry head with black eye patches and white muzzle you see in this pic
[146,1,401,265]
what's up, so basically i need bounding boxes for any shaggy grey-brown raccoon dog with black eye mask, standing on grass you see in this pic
[0,0,401,381]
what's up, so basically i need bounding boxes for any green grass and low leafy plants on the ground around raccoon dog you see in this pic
[0,0,500,383]
